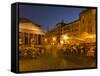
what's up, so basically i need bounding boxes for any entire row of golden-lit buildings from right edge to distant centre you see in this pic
[45,9,96,44]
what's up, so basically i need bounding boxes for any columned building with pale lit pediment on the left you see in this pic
[19,18,45,47]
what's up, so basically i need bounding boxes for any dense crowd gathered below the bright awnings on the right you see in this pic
[59,43,96,57]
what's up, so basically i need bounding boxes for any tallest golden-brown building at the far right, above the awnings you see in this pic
[80,9,96,34]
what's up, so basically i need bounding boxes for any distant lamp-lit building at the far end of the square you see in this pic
[45,22,66,44]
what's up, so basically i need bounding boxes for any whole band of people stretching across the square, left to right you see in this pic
[19,43,96,57]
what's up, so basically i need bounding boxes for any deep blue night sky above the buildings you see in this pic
[19,5,86,31]
